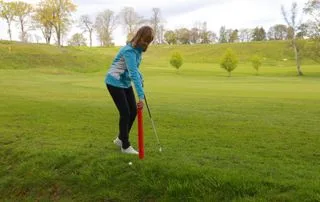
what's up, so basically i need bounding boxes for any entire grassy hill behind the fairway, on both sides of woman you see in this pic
[0,41,313,72]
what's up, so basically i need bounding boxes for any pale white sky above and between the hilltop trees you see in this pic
[0,0,307,45]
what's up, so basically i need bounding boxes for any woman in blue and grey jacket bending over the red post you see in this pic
[105,26,154,154]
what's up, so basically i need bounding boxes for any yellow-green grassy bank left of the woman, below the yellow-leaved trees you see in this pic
[0,42,116,72]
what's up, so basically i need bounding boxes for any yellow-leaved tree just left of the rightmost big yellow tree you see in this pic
[32,1,53,44]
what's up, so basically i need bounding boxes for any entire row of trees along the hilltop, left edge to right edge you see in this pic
[0,0,320,46]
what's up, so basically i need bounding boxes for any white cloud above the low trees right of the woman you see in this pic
[167,0,306,32]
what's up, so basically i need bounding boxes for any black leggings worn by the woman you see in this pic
[107,84,137,149]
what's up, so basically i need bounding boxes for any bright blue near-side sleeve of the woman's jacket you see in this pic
[123,50,144,99]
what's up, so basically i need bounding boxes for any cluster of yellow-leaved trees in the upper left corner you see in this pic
[0,0,77,45]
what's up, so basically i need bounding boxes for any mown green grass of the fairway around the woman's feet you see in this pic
[0,41,320,201]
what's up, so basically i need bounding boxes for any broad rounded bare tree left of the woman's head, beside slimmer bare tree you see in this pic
[95,9,118,46]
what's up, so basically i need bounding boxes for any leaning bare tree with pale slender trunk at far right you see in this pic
[281,2,303,76]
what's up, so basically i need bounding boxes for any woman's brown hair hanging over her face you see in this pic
[130,26,154,52]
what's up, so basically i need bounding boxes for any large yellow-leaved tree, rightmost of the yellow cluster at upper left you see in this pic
[41,0,77,46]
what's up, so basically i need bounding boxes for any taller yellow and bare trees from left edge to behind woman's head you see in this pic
[0,0,164,46]
